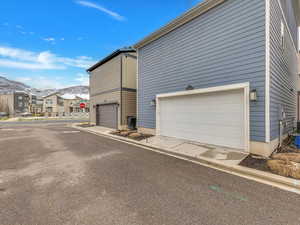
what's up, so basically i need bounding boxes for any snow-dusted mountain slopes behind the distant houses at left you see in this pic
[0,76,89,97]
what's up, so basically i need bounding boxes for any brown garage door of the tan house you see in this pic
[97,104,118,129]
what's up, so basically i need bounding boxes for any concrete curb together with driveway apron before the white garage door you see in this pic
[72,124,300,194]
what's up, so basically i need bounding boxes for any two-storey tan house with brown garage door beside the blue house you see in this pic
[87,48,136,129]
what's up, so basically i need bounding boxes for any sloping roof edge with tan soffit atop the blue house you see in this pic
[133,0,226,49]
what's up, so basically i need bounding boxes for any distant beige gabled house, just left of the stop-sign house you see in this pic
[43,93,64,116]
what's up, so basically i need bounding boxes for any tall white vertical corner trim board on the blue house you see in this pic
[265,0,271,143]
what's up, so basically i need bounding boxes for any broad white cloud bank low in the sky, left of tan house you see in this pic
[0,46,95,70]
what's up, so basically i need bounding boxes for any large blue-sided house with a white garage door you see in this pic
[135,0,300,156]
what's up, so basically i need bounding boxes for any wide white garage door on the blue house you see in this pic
[157,89,246,150]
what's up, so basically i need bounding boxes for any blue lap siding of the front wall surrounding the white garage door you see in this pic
[138,0,265,141]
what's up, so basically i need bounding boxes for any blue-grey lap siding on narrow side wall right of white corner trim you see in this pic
[270,0,298,140]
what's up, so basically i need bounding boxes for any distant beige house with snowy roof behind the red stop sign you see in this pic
[61,94,90,115]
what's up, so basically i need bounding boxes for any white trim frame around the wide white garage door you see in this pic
[156,82,250,152]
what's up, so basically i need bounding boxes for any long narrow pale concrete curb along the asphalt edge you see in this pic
[72,124,300,194]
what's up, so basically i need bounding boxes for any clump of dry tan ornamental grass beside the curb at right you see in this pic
[267,159,300,179]
